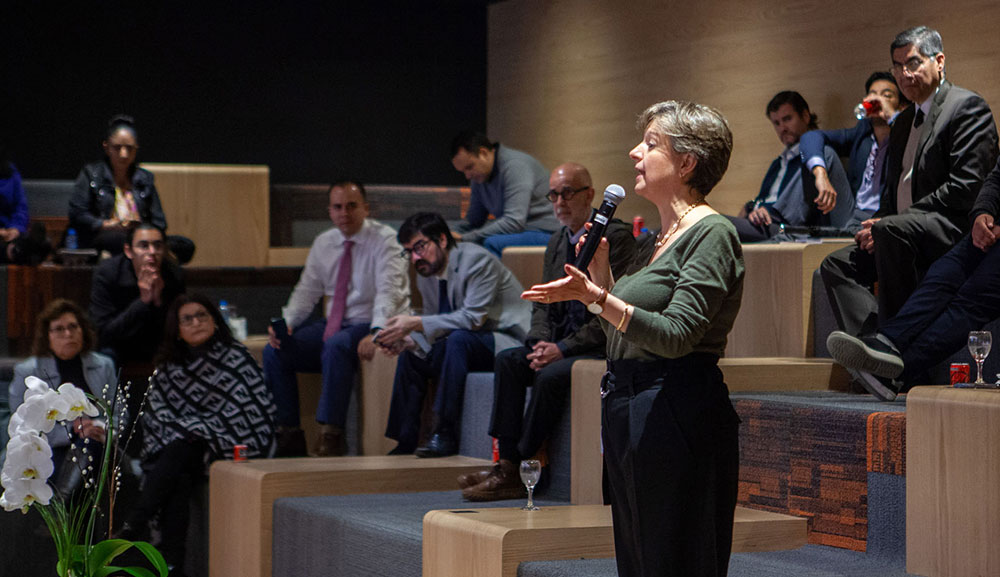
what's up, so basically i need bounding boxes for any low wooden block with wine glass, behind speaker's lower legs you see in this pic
[423,505,806,577]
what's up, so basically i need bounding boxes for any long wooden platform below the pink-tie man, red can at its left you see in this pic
[209,455,490,577]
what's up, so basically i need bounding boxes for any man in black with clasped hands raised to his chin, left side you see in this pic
[90,222,184,366]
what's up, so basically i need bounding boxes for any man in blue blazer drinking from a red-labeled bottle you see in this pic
[799,72,910,233]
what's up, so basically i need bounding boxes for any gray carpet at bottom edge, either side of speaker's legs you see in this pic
[517,545,911,577]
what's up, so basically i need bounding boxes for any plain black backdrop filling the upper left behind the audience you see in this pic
[0,0,486,184]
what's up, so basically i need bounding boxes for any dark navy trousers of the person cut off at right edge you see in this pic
[879,235,1000,384]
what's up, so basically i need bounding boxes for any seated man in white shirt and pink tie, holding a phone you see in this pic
[263,181,409,457]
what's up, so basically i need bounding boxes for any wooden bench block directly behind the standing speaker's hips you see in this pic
[570,357,848,505]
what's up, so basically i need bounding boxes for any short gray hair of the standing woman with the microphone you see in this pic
[638,100,733,196]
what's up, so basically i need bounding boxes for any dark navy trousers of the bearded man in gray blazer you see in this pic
[385,329,493,450]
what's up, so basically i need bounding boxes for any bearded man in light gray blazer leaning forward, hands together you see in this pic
[376,212,531,457]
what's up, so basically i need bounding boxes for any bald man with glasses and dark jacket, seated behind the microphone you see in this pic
[458,162,635,501]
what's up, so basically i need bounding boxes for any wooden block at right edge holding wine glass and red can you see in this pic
[906,387,1000,577]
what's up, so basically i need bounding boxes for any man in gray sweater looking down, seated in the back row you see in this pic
[451,131,559,258]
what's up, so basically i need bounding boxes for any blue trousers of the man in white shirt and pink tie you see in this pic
[263,320,370,428]
